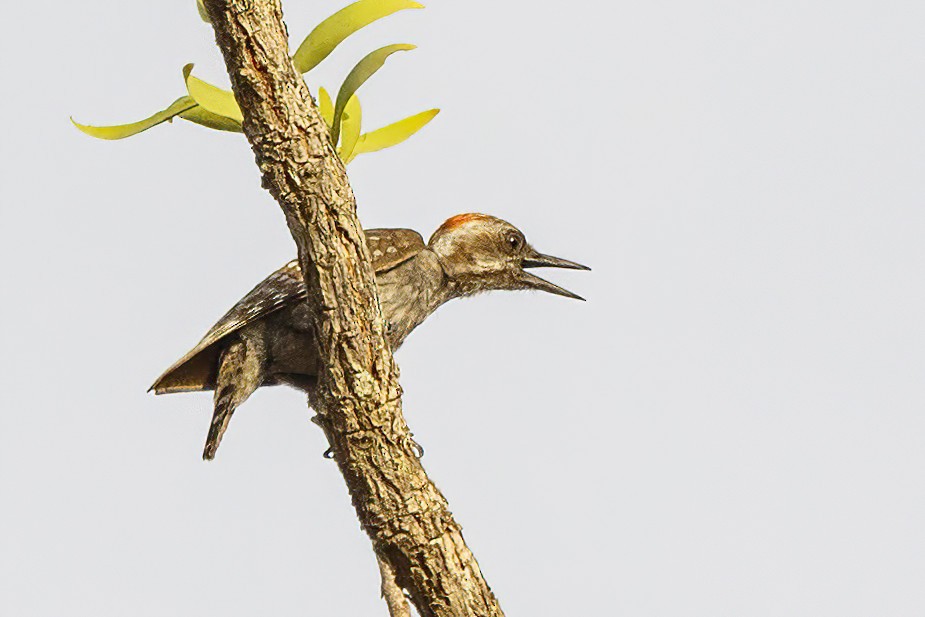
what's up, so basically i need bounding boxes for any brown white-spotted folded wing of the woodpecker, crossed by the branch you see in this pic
[151,229,424,394]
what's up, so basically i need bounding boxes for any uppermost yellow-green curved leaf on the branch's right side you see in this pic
[292,0,424,73]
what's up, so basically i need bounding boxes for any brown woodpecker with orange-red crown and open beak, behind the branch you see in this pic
[151,213,590,460]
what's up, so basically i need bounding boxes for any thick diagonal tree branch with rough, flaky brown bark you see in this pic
[205,0,503,617]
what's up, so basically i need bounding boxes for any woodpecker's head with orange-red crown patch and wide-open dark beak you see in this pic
[428,214,590,300]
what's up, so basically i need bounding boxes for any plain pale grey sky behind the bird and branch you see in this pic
[0,0,925,617]
